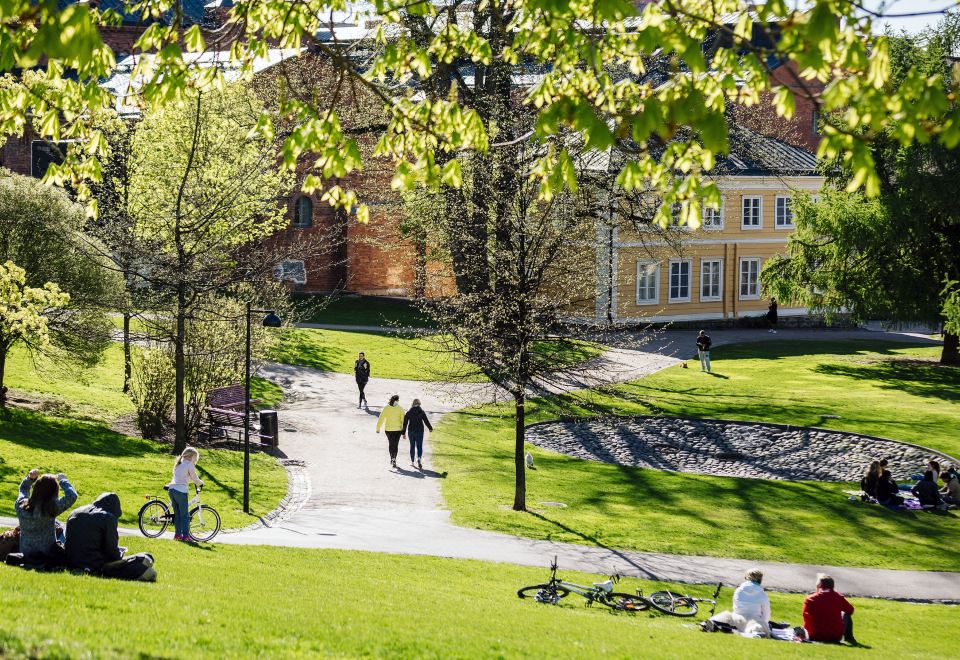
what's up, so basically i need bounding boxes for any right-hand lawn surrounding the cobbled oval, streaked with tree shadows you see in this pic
[432,342,960,570]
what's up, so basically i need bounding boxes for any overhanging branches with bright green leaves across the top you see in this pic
[0,0,960,224]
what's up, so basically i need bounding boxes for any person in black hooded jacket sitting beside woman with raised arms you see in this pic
[64,493,157,582]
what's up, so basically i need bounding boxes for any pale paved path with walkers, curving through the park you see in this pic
[210,330,960,602]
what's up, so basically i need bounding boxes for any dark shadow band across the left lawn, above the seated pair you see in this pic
[0,408,158,458]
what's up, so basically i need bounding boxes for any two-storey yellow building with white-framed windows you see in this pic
[596,136,823,323]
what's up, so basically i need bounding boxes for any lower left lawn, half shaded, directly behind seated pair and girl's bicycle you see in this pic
[0,408,287,528]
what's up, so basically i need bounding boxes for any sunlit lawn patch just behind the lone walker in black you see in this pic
[270,328,603,381]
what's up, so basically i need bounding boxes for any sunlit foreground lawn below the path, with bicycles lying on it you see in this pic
[0,538,957,658]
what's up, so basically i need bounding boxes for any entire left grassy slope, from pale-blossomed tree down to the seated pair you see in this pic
[0,345,287,527]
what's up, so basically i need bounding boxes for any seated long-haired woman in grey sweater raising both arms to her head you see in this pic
[15,469,77,565]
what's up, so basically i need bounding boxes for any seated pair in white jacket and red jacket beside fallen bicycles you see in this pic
[704,568,857,644]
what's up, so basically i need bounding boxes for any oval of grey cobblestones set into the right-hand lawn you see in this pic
[527,417,957,481]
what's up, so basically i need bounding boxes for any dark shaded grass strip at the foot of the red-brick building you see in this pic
[294,296,432,328]
